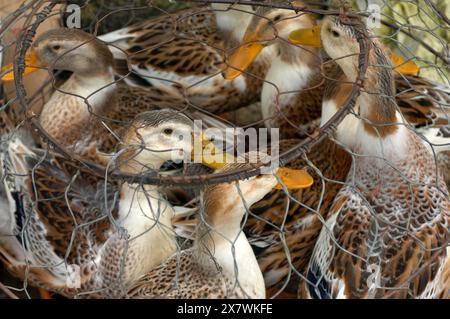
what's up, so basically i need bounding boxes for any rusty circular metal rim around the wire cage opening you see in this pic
[10,0,392,187]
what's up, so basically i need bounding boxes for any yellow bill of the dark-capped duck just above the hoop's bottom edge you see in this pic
[191,134,234,170]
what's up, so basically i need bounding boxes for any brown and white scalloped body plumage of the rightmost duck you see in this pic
[308,135,450,298]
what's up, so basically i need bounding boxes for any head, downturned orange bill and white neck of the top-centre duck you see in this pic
[224,1,324,139]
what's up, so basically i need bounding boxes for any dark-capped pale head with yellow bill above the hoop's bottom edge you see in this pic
[119,109,234,173]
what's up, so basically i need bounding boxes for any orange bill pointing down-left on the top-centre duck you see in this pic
[224,33,264,80]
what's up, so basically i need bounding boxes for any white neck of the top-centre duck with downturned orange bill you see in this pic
[261,41,319,127]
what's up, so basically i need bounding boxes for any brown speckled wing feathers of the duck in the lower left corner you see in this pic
[0,148,118,295]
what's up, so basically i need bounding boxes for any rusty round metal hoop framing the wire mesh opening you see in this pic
[5,1,367,187]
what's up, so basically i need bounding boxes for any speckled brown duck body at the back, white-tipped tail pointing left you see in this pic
[99,3,273,114]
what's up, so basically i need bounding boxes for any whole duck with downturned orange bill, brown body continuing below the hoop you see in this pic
[217,1,351,298]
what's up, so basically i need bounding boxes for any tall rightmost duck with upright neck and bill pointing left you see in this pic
[290,9,450,299]
